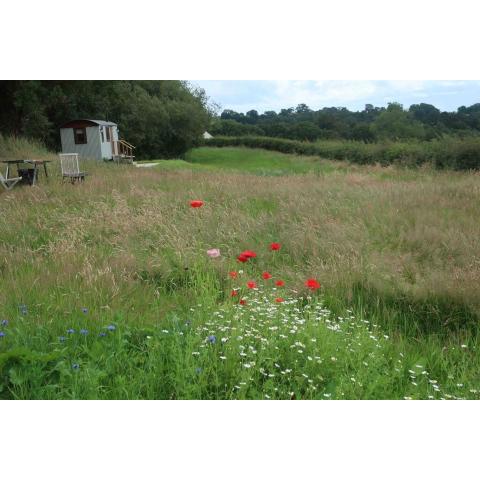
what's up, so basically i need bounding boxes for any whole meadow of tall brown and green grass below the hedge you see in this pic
[0,145,480,399]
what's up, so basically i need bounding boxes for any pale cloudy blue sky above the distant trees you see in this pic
[192,80,480,113]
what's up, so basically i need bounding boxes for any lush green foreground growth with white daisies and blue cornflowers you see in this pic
[0,286,477,399]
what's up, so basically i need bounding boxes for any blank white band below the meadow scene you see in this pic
[0,401,480,480]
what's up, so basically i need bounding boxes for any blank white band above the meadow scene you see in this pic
[0,0,479,80]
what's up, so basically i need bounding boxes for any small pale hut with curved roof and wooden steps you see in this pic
[60,119,135,160]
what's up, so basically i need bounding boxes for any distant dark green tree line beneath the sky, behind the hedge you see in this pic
[209,102,480,143]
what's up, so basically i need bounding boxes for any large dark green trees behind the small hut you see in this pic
[0,80,212,158]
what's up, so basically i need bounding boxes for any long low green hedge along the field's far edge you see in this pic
[202,136,480,170]
